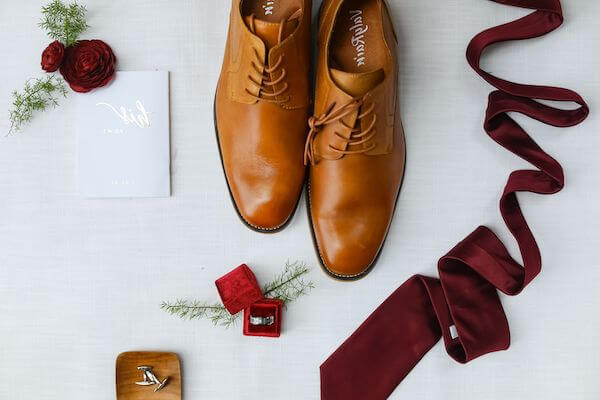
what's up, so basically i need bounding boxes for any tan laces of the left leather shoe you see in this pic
[246,15,290,104]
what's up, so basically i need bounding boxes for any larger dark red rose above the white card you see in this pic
[60,40,117,93]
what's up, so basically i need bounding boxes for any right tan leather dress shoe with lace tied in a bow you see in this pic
[305,0,405,280]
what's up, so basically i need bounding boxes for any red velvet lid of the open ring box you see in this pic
[215,264,263,315]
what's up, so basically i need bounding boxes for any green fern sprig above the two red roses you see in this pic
[39,0,89,47]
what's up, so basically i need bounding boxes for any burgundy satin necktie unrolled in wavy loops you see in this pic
[321,0,589,400]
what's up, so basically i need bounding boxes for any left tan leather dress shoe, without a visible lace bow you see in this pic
[215,0,312,232]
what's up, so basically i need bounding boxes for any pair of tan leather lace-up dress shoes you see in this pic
[215,0,405,279]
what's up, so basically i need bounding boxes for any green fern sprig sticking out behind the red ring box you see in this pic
[160,262,315,328]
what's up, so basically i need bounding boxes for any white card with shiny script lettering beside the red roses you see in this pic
[74,71,171,198]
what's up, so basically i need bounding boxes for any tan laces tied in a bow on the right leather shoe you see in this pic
[304,98,377,165]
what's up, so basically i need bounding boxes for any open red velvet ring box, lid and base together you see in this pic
[215,264,283,337]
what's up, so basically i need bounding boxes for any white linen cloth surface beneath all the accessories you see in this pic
[0,0,600,400]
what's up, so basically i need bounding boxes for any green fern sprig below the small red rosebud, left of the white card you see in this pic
[8,75,67,134]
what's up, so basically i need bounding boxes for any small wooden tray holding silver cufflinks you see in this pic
[116,351,181,400]
